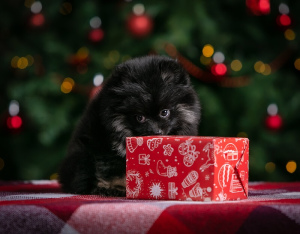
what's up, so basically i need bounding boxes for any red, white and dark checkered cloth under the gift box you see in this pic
[0,181,300,234]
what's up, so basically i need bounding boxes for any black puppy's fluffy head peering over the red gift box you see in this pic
[101,56,200,155]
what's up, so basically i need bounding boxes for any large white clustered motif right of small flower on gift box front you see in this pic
[178,139,200,167]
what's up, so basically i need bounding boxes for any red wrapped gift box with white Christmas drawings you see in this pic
[126,136,249,201]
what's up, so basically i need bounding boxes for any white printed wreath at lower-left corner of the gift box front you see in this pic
[126,170,143,198]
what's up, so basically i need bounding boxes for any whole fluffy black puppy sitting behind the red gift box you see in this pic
[59,56,200,196]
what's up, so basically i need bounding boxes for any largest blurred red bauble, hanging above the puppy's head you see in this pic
[127,14,153,38]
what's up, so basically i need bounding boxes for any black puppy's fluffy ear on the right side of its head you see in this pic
[160,60,190,86]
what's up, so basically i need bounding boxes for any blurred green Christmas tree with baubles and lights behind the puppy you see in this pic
[0,0,300,181]
